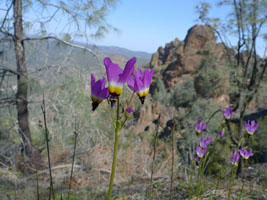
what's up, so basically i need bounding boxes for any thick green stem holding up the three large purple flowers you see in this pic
[108,97,121,200]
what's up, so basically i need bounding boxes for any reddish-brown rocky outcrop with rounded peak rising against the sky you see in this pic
[150,25,229,89]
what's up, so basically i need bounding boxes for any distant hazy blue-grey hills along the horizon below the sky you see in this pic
[0,39,151,69]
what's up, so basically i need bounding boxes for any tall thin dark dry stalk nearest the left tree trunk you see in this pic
[41,95,55,199]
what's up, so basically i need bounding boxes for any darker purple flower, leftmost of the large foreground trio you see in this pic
[91,74,109,111]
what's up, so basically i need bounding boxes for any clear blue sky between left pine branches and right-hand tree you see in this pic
[95,0,232,53]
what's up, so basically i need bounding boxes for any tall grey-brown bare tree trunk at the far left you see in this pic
[13,0,32,156]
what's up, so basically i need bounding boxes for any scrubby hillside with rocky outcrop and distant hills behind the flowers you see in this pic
[0,25,267,200]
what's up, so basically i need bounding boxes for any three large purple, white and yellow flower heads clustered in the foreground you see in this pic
[91,57,154,110]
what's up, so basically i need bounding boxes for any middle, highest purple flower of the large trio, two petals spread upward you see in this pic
[104,57,136,96]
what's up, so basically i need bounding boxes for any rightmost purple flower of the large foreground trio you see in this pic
[127,68,155,104]
